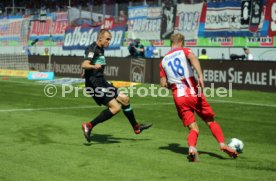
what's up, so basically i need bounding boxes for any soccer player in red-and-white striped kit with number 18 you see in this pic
[160,33,238,161]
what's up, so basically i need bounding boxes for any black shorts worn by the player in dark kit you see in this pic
[85,77,119,105]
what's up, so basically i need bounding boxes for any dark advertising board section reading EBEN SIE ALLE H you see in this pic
[201,61,276,92]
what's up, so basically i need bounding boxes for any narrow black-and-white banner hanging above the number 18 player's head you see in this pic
[160,6,176,40]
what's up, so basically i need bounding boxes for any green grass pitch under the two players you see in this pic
[0,78,276,181]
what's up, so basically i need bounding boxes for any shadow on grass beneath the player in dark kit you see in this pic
[84,134,150,146]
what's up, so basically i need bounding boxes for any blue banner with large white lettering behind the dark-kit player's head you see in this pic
[63,26,126,50]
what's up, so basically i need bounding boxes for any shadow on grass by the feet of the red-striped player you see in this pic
[159,143,226,159]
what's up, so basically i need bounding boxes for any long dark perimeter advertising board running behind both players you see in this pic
[28,56,276,92]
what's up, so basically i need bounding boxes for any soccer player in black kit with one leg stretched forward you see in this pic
[81,29,152,142]
